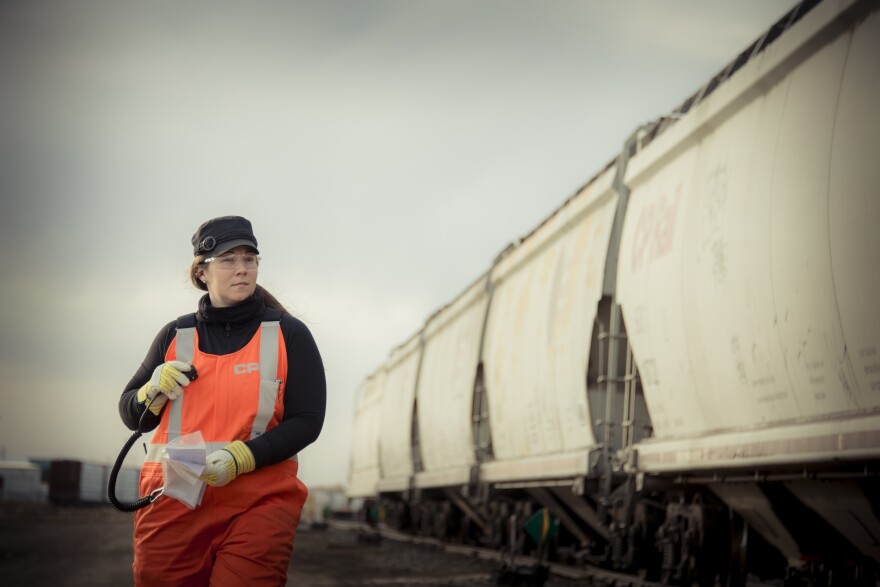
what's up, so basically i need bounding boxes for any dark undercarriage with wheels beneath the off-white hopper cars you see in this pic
[372,463,880,587]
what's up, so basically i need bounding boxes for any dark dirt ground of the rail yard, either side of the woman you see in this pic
[0,503,573,587]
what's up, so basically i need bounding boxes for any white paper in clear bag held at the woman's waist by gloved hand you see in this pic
[162,431,207,510]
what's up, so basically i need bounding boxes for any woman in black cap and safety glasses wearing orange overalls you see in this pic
[119,216,326,586]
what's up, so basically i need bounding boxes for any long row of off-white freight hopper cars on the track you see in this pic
[347,0,880,586]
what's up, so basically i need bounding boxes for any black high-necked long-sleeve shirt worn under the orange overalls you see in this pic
[119,292,327,467]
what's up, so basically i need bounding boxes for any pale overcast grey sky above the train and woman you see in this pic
[0,0,796,486]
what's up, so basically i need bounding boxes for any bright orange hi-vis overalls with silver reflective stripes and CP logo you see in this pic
[133,315,308,587]
